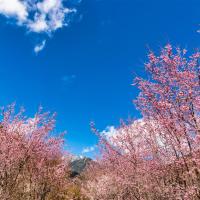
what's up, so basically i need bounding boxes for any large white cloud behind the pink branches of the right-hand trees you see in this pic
[101,119,167,153]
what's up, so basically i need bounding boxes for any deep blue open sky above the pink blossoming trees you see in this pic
[0,0,200,156]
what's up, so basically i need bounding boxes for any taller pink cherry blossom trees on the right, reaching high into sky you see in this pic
[86,45,200,200]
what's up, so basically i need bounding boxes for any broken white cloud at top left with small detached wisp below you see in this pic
[0,0,79,53]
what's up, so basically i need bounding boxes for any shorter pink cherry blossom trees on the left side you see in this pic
[0,106,72,200]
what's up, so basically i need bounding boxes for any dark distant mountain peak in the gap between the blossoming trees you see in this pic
[70,157,92,178]
